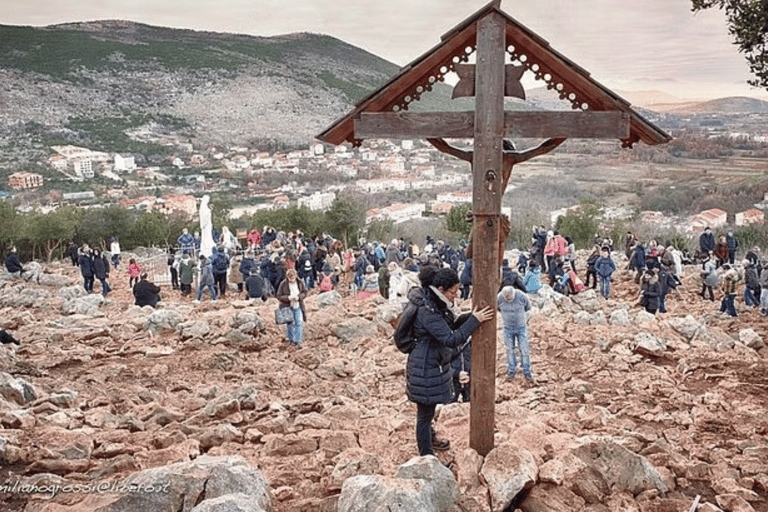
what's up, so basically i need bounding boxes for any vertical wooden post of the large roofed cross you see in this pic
[469,13,505,456]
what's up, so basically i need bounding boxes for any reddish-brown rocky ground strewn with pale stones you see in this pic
[0,253,768,512]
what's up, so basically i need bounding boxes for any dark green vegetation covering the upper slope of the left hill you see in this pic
[0,22,398,93]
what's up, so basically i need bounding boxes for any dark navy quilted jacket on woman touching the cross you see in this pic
[406,288,480,405]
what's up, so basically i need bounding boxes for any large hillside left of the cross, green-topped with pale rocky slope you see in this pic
[0,21,474,151]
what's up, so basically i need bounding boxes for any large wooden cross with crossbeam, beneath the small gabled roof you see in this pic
[354,12,630,456]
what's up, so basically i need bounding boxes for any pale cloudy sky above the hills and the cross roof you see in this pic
[6,0,768,99]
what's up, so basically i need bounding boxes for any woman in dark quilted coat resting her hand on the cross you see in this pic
[406,267,493,455]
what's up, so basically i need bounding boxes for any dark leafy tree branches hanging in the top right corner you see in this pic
[691,0,768,89]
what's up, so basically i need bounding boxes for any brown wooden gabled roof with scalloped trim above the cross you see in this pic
[317,0,671,147]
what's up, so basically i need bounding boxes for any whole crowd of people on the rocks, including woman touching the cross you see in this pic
[5,226,768,455]
